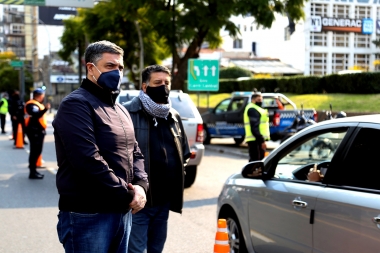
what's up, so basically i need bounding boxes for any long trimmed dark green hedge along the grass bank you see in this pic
[202,72,380,94]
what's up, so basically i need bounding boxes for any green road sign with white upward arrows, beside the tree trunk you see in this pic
[187,59,219,91]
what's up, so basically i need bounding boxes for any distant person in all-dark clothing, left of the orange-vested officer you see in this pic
[9,90,28,145]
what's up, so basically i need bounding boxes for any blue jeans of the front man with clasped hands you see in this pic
[57,211,132,253]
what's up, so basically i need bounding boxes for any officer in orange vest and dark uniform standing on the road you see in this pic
[25,88,50,179]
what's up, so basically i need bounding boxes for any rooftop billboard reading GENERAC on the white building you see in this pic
[310,16,373,34]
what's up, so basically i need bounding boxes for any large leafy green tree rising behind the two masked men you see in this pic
[59,0,304,89]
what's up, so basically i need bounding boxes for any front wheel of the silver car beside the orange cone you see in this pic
[219,212,248,253]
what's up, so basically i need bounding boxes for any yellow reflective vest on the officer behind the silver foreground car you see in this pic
[244,103,270,142]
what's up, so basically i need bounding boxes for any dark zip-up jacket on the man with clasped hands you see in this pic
[53,79,148,213]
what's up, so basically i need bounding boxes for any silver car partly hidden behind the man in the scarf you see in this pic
[117,90,205,188]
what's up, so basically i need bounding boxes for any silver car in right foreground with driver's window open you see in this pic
[217,115,380,253]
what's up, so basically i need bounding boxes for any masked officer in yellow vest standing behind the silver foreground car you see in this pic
[244,92,270,162]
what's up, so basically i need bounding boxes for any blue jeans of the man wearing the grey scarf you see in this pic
[128,204,169,253]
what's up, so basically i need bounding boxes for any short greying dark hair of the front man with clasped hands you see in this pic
[84,40,124,72]
